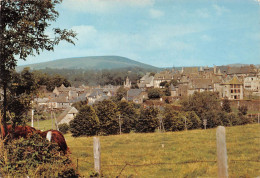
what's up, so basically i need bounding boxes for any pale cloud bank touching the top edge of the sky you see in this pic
[62,0,154,13]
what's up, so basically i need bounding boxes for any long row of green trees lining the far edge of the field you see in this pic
[69,92,252,137]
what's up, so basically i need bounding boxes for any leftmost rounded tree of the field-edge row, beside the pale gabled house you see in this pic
[70,105,99,137]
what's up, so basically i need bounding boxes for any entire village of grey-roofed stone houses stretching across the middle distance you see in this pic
[27,65,260,124]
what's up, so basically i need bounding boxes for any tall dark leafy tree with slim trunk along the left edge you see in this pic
[0,0,76,137]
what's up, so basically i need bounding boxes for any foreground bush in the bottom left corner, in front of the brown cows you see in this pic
[0,134,78,177]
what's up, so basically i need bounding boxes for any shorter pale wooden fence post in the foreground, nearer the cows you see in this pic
[93,137,101,175]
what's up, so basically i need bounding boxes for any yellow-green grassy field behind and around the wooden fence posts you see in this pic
[61,124,260,177]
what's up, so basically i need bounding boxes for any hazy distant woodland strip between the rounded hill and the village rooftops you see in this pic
[33,67,157,86]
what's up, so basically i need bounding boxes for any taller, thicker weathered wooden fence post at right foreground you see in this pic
[216,126,228,178]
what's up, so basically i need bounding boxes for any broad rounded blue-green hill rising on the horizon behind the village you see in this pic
[17,56,159,71]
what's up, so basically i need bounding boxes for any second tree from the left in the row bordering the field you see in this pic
[94,100,119,135]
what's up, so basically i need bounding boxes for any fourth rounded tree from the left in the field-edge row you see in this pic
[136,107,159,132]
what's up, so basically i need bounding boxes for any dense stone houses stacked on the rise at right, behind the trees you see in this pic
[139,65,260,100]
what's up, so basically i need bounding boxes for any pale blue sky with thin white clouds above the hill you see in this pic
[18,0,260,67]
